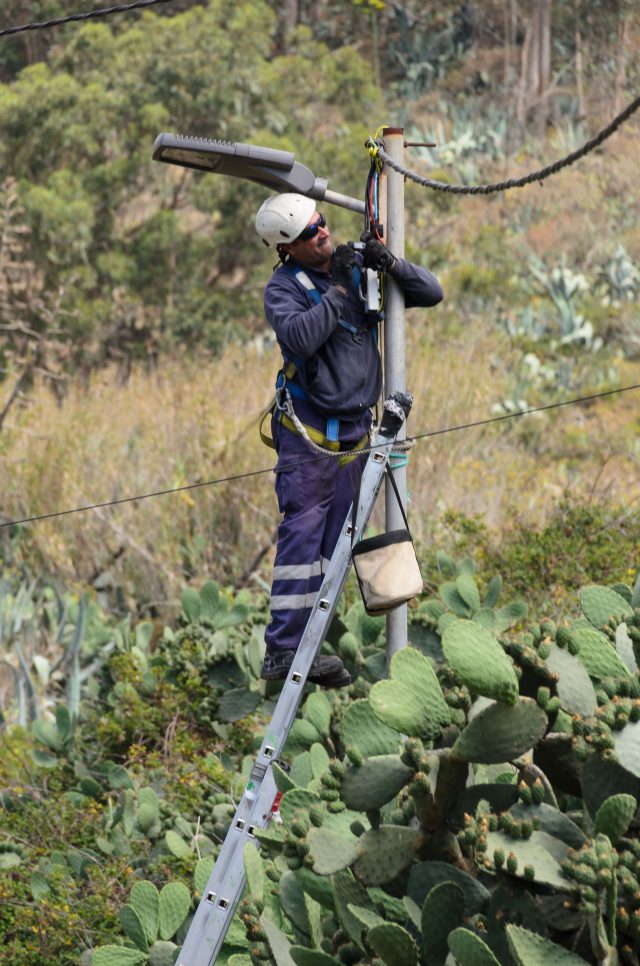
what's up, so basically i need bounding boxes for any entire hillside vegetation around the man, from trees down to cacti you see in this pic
[0,0,640,966]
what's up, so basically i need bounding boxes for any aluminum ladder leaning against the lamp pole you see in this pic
[177,392,413,966]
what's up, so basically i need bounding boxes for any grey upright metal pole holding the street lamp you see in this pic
[382,127,408,670]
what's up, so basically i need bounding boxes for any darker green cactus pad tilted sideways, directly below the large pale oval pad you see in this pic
[451,698,547,764]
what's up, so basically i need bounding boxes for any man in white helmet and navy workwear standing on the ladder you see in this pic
[256,193,442,688]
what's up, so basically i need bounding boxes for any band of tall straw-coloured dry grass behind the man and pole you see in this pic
[0,322,640,605]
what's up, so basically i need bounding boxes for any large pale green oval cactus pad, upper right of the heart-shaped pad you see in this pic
[442,620,518,705]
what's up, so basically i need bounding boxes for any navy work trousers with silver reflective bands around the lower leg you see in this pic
[265,412,371,652]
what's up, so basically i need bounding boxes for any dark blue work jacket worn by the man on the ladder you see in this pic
[264,252,442,420]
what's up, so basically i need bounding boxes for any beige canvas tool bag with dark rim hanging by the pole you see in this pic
[351,468,423,615]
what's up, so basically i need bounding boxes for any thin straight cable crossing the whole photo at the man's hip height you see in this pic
[0,383,640,530]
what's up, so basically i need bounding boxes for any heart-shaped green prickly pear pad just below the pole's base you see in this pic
[369,647,451,738]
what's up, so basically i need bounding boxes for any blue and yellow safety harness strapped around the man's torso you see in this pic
[260,263,377,467]
